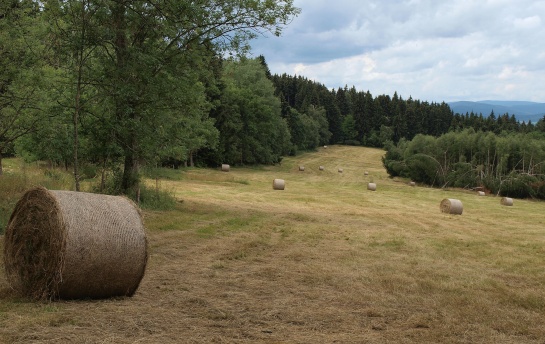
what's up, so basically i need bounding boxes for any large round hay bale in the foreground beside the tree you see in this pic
[4,187,148,299]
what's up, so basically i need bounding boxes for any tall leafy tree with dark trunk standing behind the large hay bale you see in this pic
[45,0,299,193]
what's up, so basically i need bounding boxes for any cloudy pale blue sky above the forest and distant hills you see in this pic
[250,0,545,102]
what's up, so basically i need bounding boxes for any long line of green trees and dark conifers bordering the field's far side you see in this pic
[0,0,544,200]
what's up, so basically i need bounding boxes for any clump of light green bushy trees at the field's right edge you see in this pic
[383,129,545,198]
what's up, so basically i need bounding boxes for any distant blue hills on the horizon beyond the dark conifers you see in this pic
[448,100,545,124]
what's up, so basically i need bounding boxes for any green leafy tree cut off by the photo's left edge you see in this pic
[0,0,49,175]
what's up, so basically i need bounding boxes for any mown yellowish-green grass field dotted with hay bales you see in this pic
[0,146,545,344]
